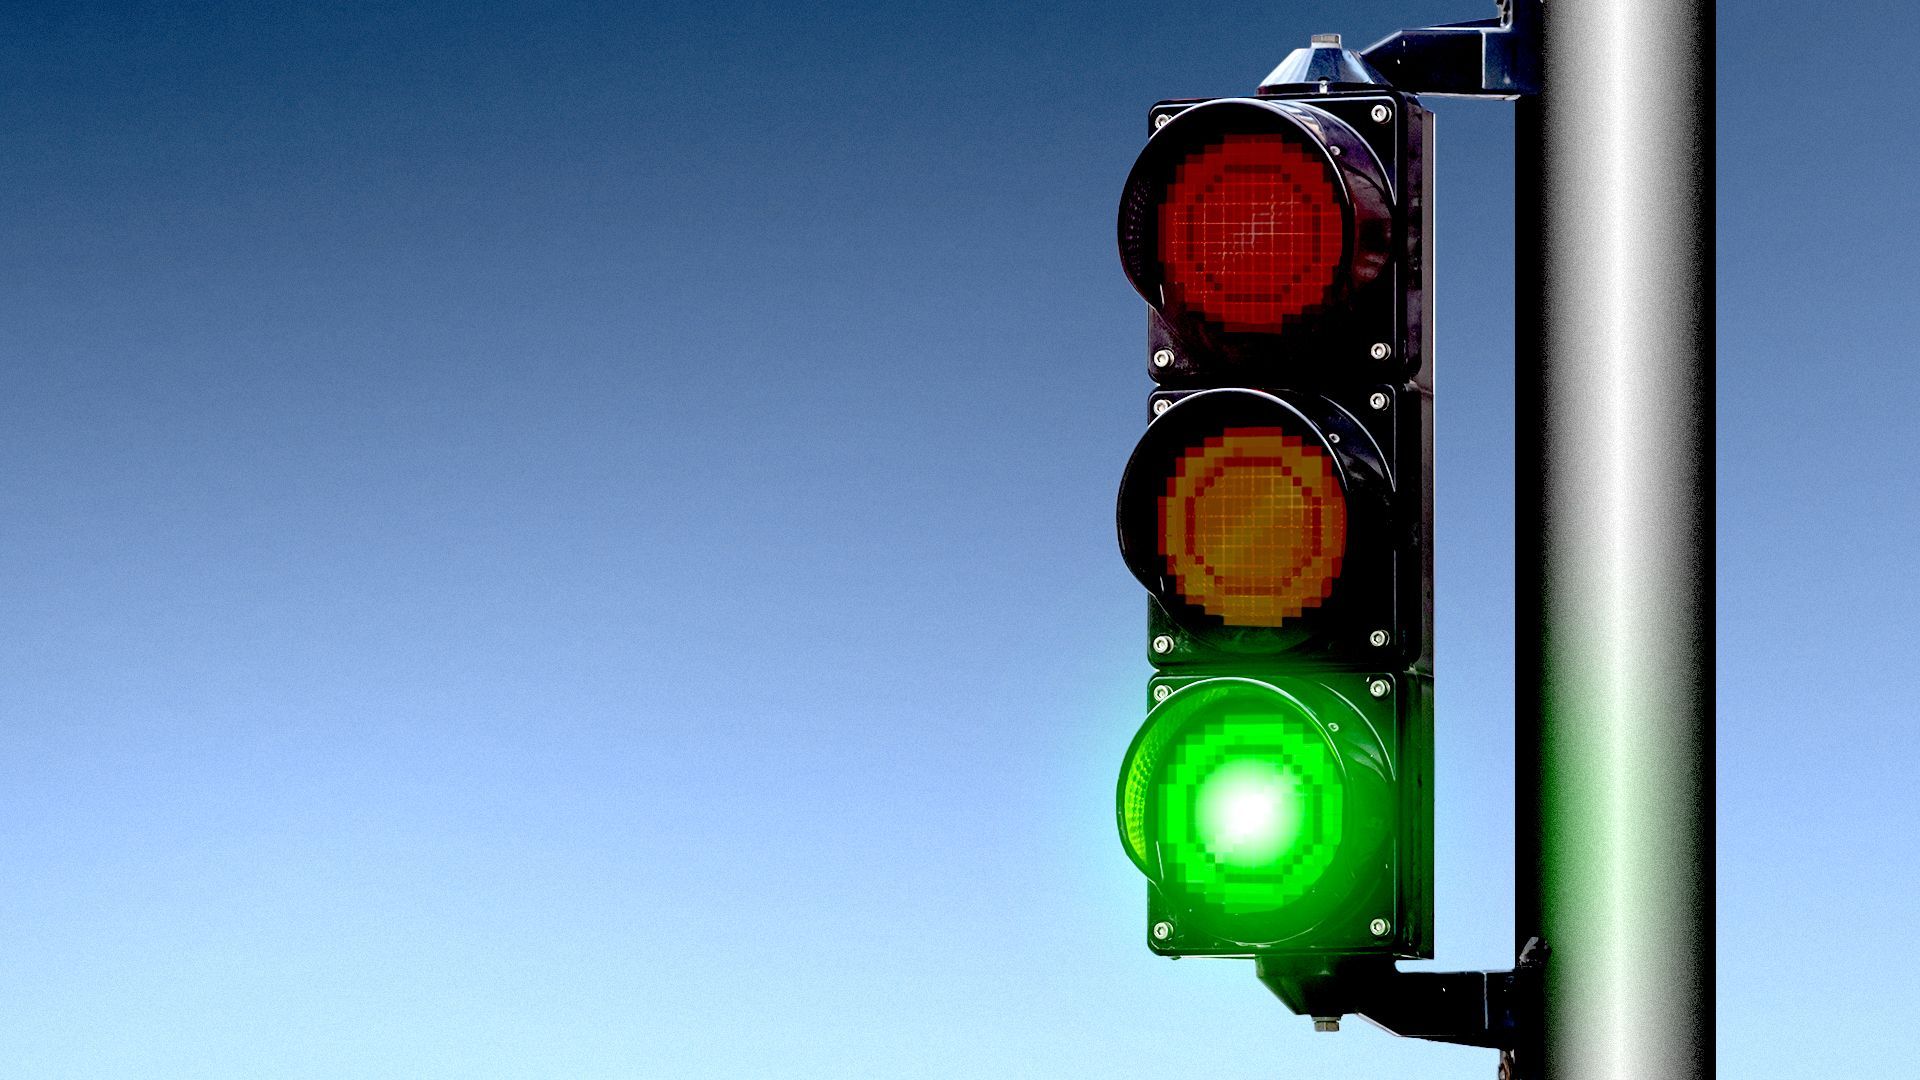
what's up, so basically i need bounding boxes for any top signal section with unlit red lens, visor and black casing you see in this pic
[1119,98,1405,367]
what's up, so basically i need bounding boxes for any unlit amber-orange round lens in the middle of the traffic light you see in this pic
[1160,427,1346,626]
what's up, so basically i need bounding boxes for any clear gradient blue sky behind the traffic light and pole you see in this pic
[0,0,1920,1080]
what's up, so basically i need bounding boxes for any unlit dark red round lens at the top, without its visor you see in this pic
[1158,133,1346,332]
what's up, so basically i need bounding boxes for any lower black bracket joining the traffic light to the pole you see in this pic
[1256,938,1548,1051]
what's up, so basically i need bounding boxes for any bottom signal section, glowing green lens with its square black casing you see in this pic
[1117,673,1432,955]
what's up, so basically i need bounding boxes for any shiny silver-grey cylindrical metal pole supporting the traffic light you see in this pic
[1513,0,1715,1080]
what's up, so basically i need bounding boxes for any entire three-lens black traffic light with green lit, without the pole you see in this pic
[1116,38,1432,965]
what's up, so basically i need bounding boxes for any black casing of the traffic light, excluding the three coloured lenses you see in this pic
[1117,62,1432,970]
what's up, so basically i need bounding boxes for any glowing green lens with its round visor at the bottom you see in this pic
[1119,678,1392,938]
